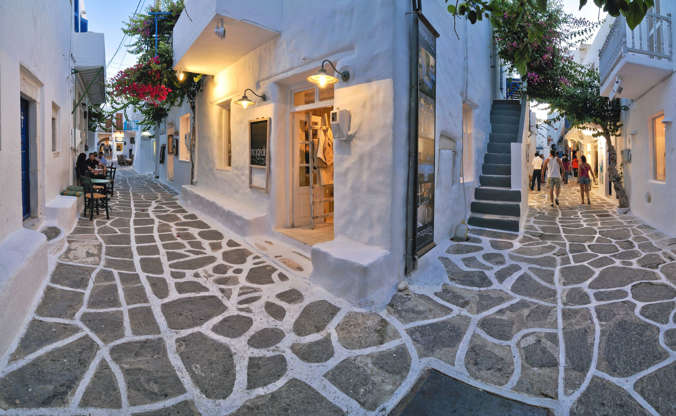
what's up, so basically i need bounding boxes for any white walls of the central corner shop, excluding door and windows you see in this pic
[160,0,492,300]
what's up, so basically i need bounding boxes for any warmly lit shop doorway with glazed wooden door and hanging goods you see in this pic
[279,88,334,246]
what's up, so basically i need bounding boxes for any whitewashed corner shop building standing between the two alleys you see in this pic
[145,0,527,305]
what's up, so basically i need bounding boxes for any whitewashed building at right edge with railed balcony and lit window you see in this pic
[599,0,676,235]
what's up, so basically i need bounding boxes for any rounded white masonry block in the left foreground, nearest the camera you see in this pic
[0,228,49,361]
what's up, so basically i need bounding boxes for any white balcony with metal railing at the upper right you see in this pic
[599,13,674,99]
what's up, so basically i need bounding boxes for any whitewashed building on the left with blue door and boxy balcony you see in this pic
[0,0,105,354]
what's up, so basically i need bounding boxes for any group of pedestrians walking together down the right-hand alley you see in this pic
[530,149,596,207]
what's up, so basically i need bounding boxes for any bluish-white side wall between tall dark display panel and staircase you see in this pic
[426,0,493,243]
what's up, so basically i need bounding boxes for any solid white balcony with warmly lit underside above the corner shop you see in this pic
[173,0,282,75]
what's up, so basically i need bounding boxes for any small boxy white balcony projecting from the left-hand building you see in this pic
[73,32,106,104]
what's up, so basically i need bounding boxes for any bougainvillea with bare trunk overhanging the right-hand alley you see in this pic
[449,0,636,208]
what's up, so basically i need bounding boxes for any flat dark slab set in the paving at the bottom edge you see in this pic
[390,370,552,416]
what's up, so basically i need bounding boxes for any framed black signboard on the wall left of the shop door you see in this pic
[249,118,270,192]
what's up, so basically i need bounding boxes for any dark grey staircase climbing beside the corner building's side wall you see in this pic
[468,100,521,232]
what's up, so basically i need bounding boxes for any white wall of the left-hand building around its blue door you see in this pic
[0,0,74,240]
